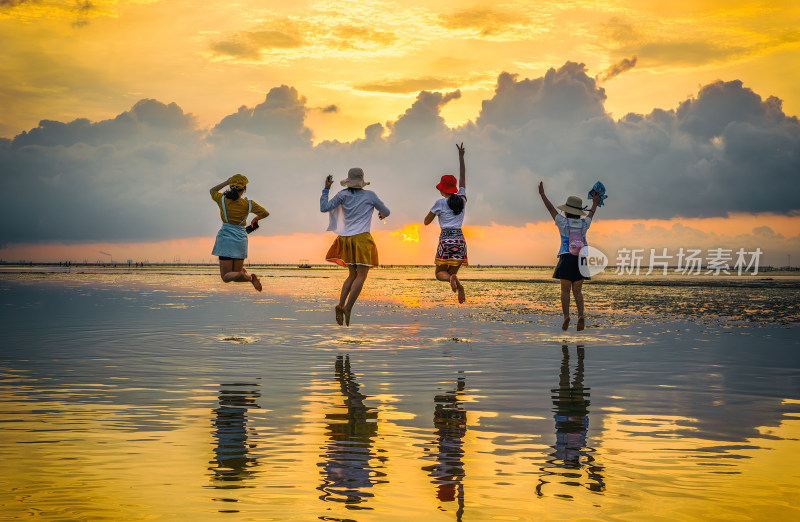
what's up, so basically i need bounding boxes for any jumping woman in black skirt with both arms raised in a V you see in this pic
[539,182,600,331]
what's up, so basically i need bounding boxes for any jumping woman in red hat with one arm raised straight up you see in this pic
[424,143,468,303]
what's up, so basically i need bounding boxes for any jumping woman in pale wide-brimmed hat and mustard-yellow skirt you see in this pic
[319,167,389,326]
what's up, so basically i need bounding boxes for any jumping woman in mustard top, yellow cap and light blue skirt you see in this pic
[209,174,269,292]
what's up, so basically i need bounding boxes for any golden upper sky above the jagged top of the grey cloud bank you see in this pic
[0,0,800,141]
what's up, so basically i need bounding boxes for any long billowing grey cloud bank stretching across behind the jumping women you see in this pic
[0,62,800,248]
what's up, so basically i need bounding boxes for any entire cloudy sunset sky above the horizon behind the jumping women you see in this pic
[0,0,800,265]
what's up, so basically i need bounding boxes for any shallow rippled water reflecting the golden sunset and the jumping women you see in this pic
[0,269,800,521]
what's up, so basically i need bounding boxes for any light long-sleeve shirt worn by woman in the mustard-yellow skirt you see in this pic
[319,188,389,236]
